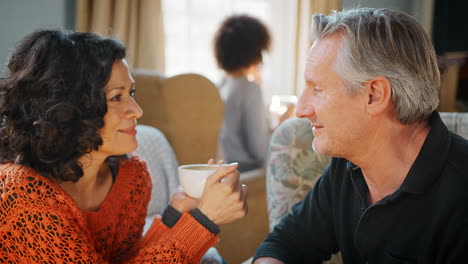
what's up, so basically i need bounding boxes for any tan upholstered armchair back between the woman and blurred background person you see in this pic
[133,71,224,165]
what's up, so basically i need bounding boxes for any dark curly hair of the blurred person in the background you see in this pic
[214,15,271,72]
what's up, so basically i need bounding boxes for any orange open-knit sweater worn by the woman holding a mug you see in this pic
[0,156,217,263]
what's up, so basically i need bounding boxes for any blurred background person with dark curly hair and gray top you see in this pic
[214,15,271,172]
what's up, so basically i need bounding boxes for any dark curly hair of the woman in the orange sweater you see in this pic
[0,30,125,182]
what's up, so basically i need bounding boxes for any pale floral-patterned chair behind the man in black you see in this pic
[266,113,468,263]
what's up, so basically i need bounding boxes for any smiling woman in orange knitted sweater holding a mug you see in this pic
[0,30,246,263]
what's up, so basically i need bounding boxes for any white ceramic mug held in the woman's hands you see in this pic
[179,164,223,199]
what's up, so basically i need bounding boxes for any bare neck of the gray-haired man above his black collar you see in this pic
[351,118,430,204]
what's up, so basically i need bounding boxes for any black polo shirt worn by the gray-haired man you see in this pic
[255,112,468,264]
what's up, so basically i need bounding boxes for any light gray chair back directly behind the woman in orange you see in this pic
[135,125,223,264]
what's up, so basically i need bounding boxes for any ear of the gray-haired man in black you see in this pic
[366,76,392,115]
